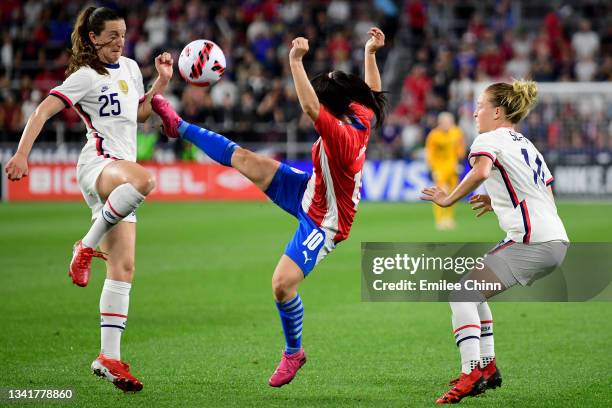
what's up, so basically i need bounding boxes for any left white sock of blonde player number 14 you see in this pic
[450,302,480,374]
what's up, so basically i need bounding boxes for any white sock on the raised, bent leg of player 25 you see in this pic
[81,183,145,248]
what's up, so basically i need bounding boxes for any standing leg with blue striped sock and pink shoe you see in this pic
[268,255,306,387]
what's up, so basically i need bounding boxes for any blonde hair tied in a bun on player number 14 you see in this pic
[485,79,538,123]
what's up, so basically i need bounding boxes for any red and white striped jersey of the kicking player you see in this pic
[302,103,374,242]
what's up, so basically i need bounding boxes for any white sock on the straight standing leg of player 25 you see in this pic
[100,279,132,360]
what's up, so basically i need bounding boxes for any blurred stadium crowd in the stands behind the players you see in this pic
[0,0,612,157]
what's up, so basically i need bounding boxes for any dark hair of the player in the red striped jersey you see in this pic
[310,71,387,128]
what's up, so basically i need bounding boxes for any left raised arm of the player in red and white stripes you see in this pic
[289,37,320,122]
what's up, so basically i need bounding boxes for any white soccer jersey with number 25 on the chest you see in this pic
[49,57,144,164]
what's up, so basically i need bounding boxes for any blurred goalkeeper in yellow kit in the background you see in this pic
[425,112,465,230]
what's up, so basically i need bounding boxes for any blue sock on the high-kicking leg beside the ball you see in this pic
[178,120,238,167]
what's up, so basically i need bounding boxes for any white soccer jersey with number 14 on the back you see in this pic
[468,128,569,243]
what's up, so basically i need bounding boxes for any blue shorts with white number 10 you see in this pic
[266,163,336,277]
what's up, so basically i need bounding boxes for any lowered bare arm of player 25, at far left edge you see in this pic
[4,96,64,180]
